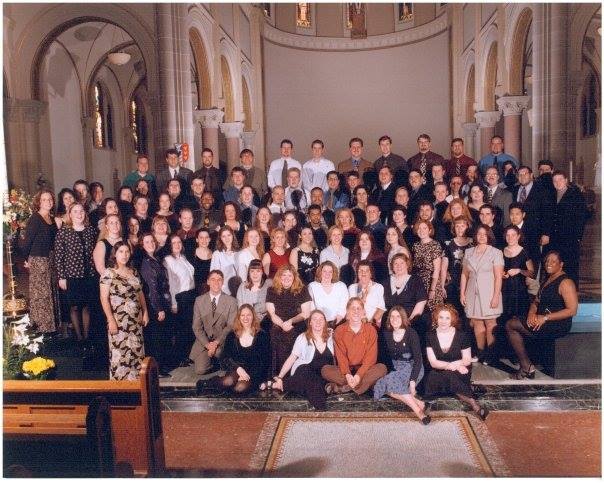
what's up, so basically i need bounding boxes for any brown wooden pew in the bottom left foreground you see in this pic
[3,357,165,476]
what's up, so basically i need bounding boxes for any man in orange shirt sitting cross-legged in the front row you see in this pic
[321,297,388,395]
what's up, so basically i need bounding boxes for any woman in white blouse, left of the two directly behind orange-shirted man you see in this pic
[308,260,349,328]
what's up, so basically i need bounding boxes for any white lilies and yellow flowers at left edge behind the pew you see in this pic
[3,315,54,379]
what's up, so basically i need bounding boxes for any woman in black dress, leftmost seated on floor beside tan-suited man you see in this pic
[218,304,270,394]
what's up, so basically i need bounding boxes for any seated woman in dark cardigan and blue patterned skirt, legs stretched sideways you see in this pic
[373,305,430,424]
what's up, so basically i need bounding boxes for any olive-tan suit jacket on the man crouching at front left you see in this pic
[189,292,237,360]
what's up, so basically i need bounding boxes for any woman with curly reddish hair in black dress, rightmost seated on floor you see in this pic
[425,304,489,421]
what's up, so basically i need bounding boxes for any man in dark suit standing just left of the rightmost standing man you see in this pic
[508,166,555,270]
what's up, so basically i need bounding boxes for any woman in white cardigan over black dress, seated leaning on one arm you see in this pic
[268,310,334,411]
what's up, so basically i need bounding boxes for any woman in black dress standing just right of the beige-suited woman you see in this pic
[501,225,534,320]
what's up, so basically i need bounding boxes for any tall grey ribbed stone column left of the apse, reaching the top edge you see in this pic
[156,3,195,169]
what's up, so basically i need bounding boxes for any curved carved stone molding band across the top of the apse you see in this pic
[262,15,447,51]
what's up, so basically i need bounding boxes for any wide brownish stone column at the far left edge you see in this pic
[2,99,47,193]
